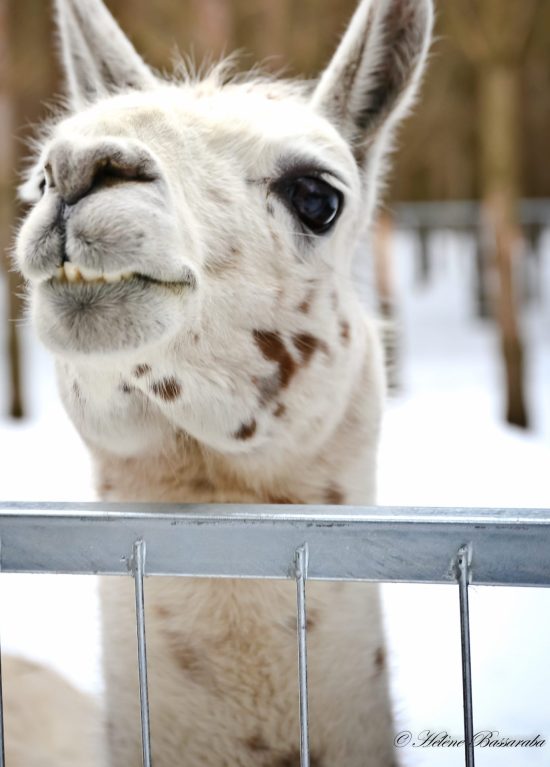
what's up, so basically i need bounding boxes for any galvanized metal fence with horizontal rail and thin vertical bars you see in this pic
[0,503,550,767]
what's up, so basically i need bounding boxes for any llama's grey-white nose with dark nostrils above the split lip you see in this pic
[44,139,158,205]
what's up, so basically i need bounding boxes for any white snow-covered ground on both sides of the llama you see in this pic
[0,232,550,767]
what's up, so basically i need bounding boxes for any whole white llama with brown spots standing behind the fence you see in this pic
[16,0,433,767]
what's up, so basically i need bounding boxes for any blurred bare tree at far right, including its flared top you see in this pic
[449,0,540,427]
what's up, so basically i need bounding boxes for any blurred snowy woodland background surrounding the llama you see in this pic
[0,0,550,767]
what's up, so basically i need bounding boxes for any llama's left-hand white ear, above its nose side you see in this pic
[56,0,155,108]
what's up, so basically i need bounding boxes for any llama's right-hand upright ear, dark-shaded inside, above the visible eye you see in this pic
[313,0,433,161]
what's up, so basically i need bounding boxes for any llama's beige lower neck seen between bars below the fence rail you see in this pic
[102,578,392,767]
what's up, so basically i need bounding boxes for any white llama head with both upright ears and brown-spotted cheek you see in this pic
[16,0,432,460]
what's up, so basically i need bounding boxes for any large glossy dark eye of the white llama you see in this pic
[283,176,342,234]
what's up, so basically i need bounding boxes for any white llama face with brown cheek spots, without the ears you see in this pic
[19,84,365,451]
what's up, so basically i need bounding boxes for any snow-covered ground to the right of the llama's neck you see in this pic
[379,232,550,767]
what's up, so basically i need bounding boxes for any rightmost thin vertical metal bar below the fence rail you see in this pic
[456,544,475,767]
